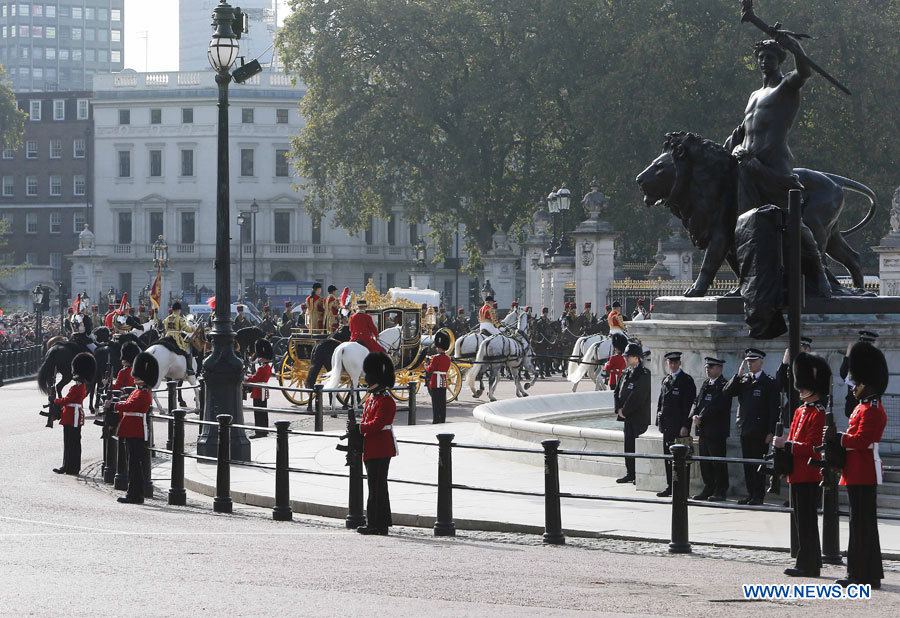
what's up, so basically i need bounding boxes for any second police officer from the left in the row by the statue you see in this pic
[656,352,697,498]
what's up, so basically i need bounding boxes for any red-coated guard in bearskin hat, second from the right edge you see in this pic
[772,352,831,577]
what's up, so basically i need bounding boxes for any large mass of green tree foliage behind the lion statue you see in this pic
[278,0,900,268]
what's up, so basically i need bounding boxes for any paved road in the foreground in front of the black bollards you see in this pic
[0,384,900,616]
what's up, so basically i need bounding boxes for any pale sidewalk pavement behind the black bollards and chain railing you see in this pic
[171,422,900,558]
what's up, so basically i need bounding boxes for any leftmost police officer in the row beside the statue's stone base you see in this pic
[614,343,651,483]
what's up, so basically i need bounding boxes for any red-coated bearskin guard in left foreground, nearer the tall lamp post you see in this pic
[115,352,159,504]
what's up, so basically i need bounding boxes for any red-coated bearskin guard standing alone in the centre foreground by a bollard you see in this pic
[356,352,397,535]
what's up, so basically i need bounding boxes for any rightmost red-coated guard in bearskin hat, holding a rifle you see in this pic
[825,341,888,589]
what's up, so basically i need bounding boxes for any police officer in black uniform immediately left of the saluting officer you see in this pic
[691,356,732,502]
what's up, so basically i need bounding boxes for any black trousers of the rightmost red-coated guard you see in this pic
[847,485,884,584]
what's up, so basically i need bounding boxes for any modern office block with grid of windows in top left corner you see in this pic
[0,0,125,92]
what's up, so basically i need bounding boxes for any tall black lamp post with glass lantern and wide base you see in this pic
[197,0,250,461]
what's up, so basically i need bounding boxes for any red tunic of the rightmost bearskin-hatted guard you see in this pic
[841,399,887,485]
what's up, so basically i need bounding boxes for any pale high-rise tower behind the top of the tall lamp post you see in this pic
[178,0,279,71]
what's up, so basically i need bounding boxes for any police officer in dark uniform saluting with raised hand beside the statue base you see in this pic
[724,348,781,504]
